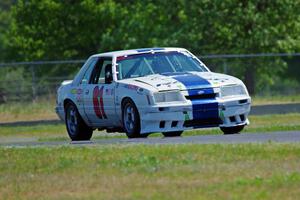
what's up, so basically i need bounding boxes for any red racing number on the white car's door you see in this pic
[93,86,107,119]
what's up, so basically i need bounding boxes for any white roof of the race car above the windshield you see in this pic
[92,47,187,57]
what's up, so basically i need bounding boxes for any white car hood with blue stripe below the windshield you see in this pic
[118,72,241,91]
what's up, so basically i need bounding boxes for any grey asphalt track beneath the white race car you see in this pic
[0,131,300,147]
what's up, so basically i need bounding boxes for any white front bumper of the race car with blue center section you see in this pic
[140,96,251,133]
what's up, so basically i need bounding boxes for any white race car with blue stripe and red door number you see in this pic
[56,48,251,140]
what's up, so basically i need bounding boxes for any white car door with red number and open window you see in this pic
[83,57,116,127]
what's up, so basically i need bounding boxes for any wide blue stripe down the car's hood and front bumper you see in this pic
[164,73,219,124]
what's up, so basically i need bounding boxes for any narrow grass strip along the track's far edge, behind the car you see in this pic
[0,114,300,142]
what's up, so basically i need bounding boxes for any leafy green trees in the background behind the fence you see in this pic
[0,0,300,93]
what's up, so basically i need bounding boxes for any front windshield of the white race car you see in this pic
[117,52,207,80]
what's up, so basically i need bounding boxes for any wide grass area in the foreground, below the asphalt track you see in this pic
[0,143,300,200]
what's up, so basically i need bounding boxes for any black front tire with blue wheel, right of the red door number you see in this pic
[122,99,148,138]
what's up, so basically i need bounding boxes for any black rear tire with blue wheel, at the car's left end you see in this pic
[65,102,93,141]
